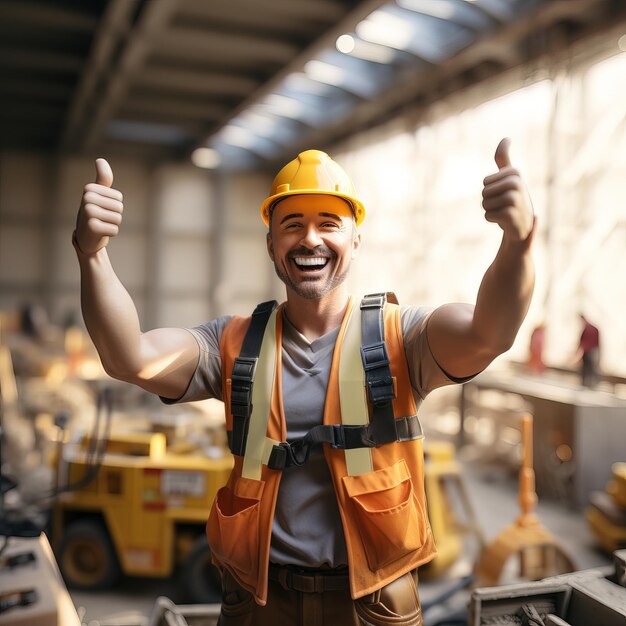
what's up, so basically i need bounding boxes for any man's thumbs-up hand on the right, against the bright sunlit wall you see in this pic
[483,137,535,243]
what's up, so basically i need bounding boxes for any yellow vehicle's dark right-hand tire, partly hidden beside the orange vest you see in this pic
[181,535,222,604]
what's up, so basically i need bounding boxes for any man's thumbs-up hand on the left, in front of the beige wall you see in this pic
[74,159,124,254]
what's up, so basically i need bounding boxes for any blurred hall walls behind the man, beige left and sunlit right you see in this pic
[0,36,626,376]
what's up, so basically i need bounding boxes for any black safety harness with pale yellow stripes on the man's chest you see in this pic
[229,293,423,478]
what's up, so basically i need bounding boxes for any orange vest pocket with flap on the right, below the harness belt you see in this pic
[343,459,426,571]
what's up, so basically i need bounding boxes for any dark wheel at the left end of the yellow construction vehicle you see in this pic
[58,520,120,589]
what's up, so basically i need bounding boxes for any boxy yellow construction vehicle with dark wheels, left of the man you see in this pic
[52,433,233,602]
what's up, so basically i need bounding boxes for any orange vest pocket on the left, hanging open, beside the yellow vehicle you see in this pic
[207,477,265,577]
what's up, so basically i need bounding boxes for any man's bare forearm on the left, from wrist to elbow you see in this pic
[77,248,141,380]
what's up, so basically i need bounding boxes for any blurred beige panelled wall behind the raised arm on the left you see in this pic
[0,152,278,328]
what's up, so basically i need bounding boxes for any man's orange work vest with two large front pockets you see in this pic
[212,294,435,605]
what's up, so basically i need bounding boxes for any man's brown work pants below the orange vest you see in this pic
[218,570,422,626]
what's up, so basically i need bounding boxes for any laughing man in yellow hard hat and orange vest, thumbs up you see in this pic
[73,139,534,626]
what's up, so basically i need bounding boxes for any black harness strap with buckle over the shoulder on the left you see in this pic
[230,300,278,456]
